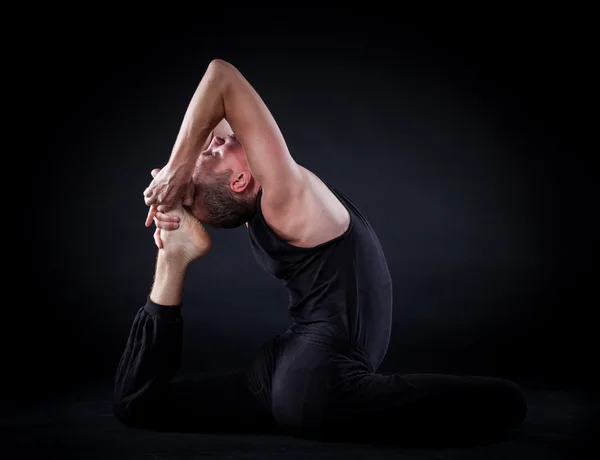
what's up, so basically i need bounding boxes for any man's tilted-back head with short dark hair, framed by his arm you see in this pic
[190,135,260,228]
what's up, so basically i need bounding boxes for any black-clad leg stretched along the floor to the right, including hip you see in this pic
[272,338,526,442]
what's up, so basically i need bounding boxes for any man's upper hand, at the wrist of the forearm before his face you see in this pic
[144,162,194,227]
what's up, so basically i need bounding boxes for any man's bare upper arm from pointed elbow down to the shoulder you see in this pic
[211,59,303,205]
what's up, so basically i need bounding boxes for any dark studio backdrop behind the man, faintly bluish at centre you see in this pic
[18,7,597,401]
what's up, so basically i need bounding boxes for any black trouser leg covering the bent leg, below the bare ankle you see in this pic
[113,300,270,431]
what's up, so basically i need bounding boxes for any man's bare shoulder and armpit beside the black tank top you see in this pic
[261,166,350,247]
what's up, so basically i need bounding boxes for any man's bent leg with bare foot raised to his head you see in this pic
[113,221,276,431]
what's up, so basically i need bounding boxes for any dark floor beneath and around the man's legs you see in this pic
[0,380,600,460]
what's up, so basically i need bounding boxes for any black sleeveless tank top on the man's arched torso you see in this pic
[248,179,392,369]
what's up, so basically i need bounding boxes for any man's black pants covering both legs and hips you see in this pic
[114,301,526,440]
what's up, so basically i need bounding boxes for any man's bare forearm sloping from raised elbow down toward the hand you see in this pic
[169,60,230,164]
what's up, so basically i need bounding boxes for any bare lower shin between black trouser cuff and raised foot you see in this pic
[150,249,189,306]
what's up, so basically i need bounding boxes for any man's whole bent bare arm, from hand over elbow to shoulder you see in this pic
[144,59,302,210]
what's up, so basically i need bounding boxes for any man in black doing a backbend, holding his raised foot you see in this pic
[114,60,526,439]
